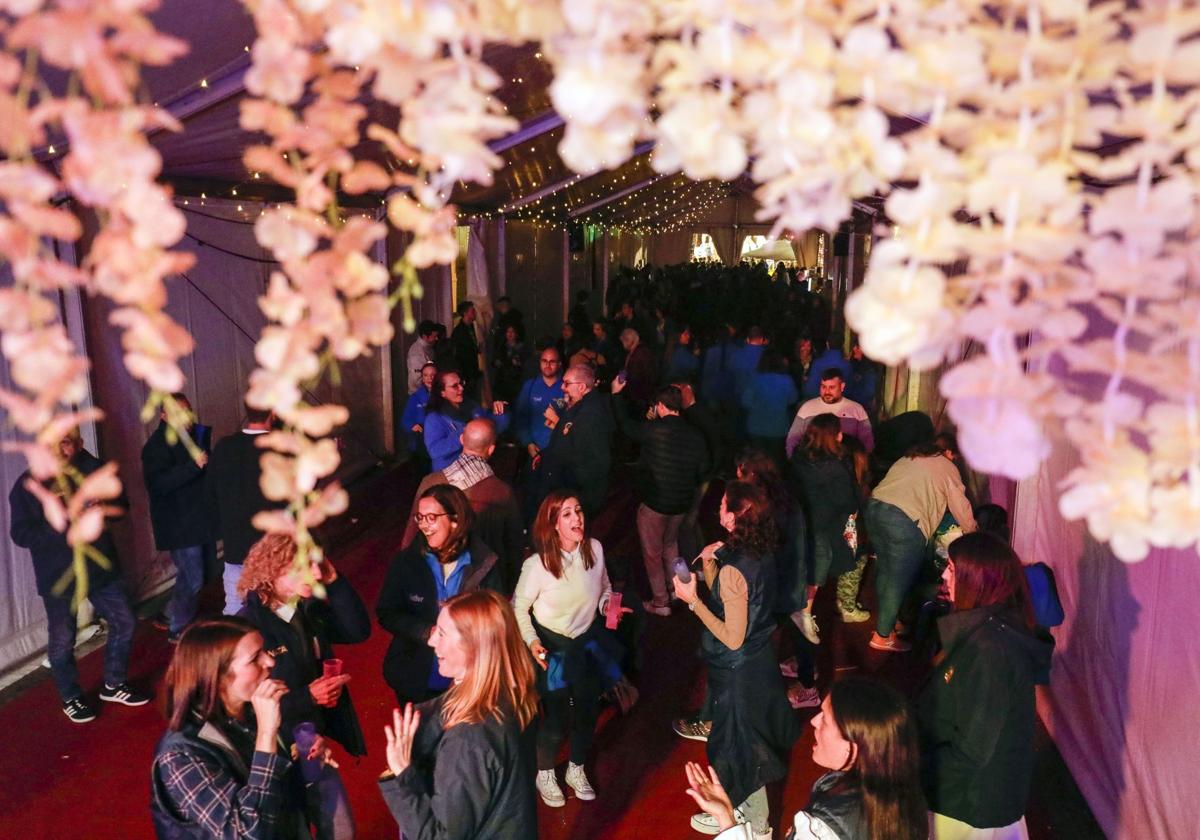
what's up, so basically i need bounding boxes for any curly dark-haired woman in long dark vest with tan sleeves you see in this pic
[674,481,799,838]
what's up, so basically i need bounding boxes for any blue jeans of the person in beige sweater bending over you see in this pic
[865,499,929,636]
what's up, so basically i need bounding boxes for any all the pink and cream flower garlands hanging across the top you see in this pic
[0,0,1200,568]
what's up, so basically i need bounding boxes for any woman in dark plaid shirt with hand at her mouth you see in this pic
[150,618,295,840]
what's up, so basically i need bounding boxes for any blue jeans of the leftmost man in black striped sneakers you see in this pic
[42,581,134,703]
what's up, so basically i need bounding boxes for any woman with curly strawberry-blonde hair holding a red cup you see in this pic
[238,534,371,840]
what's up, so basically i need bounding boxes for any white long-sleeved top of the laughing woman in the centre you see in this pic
[512,540,612,644]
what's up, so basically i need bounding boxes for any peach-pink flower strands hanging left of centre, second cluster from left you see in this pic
[241,0,564,565]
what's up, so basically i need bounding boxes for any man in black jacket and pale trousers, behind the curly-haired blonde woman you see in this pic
[204,408,276,616]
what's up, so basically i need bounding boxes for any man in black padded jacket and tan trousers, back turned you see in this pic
[612,379,709,616]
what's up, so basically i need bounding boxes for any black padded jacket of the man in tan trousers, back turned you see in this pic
[612,395,710,516]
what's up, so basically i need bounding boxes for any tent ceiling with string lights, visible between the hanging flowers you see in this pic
[126,0,844,228]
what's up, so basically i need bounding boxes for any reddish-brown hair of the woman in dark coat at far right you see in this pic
[950,532,1036,630]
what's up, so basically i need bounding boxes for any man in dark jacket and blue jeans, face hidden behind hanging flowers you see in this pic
[142,394,212,642]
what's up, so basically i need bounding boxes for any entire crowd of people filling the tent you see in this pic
[10,274,1052,840]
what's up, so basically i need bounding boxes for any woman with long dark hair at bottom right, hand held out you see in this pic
[686,677,929,840]
